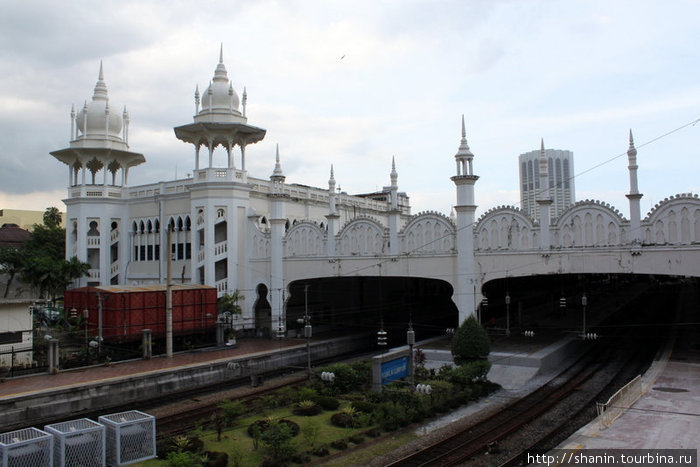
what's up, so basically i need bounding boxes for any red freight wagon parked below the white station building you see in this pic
[63,284,217,342]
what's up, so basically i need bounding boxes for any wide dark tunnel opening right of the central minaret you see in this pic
[478,274,697,335]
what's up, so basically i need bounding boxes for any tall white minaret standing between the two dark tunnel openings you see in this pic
[451,115,479,324]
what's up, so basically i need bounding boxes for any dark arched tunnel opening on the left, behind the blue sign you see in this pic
[286,276,458,345]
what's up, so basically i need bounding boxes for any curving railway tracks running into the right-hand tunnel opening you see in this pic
[386,282,672,467]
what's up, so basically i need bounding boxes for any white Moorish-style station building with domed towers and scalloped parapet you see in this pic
[51,52,700,332]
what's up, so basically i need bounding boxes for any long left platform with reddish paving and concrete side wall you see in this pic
[0,334,367,431]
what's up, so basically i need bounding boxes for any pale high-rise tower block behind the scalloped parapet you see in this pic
[518,144,576,220]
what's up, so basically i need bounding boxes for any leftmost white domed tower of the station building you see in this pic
[51,62,146,287]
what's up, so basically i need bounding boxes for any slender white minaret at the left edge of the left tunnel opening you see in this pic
[267,145,289,337]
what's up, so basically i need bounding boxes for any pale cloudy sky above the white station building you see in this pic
[0,0,700,216]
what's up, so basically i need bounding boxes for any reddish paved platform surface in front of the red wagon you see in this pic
[0,339,305,400]
